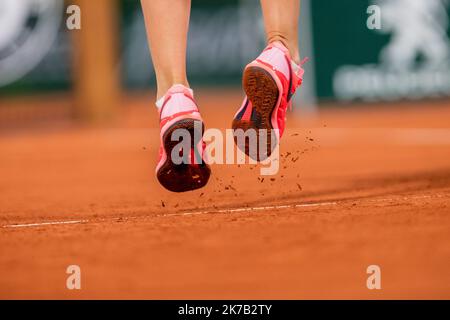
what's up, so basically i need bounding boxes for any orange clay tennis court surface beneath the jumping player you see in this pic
[0,90,450,299]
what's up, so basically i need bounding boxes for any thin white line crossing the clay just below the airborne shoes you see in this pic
[2,194,449,228]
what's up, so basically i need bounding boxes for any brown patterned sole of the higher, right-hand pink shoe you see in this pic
[232,66,279,161]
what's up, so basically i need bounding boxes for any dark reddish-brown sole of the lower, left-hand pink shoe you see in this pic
[156,119,211,192]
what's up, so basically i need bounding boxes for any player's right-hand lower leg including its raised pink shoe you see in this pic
[232,0,304,160]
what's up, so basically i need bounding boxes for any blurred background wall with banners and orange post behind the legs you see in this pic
[0,0,450,123]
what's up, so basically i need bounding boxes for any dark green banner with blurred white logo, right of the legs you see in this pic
[316,0,450,101]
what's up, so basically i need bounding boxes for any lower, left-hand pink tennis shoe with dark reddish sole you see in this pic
[156,85,211,192]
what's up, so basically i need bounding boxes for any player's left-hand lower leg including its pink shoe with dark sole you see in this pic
[141,0,210,192]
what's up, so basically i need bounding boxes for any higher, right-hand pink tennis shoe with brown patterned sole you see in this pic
[232,42,304,160]
